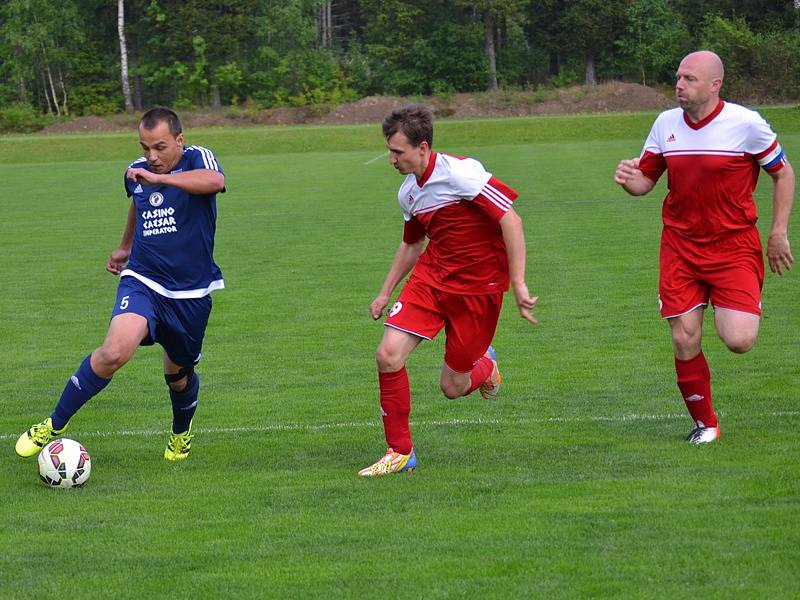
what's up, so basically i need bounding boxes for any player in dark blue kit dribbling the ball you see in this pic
[16,107,225,460]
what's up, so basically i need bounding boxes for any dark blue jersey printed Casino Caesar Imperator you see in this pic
[120,146,225,299]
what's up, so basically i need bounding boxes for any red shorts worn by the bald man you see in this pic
[658,226,764,319]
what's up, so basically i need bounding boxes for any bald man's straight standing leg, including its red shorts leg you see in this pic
[658,234,719,444]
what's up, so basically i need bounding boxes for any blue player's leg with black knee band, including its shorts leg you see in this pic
[156,296,211,461]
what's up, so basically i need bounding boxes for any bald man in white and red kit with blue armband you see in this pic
[614,51,795,444]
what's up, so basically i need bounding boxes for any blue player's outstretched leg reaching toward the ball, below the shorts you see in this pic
[16,313,148,457]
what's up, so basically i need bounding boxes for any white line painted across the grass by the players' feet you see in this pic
[0,411,800,440]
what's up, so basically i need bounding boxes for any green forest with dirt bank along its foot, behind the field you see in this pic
[0,0,800,131]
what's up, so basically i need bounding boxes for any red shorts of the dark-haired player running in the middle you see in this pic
[385,277,503,373]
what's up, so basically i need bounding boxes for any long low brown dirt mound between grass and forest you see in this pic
[40,82,675,133]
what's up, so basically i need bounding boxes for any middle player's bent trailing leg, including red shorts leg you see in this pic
[439,294,503,399]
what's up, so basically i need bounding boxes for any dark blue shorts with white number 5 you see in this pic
[111,277,211,367]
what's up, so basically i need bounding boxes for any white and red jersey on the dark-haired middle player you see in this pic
[397,152,519,294]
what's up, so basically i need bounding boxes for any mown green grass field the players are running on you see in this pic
[0,109,800,599]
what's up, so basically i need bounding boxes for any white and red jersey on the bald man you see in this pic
[639,100,786,242]
